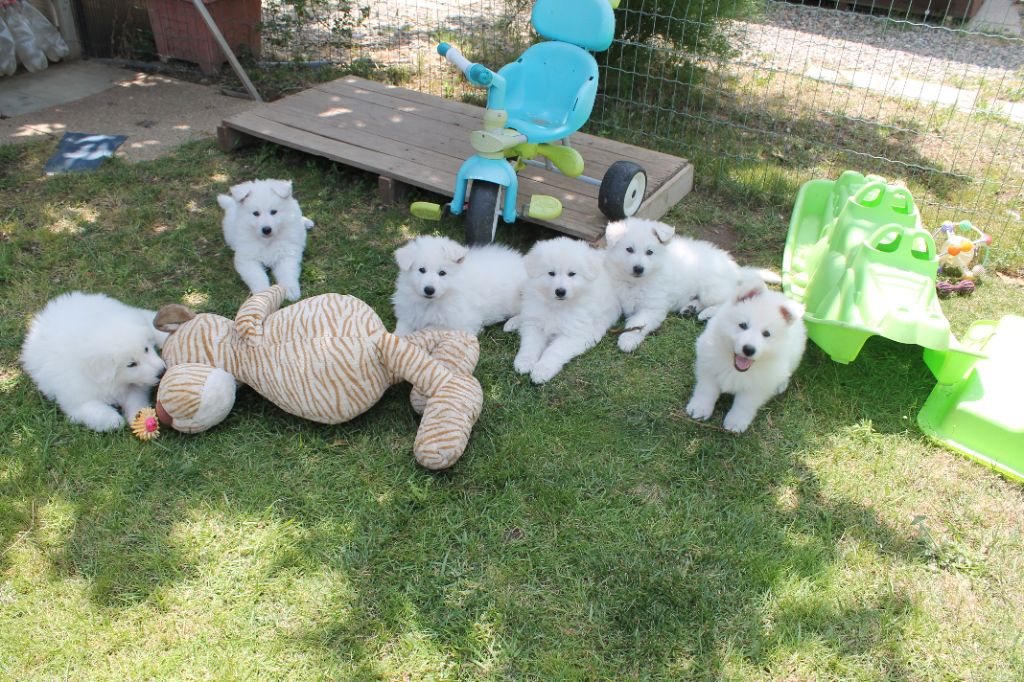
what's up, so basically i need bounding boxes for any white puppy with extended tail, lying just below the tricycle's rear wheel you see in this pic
[604,218,779,352]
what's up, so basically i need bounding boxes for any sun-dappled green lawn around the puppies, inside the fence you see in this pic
[0,143,1024,682]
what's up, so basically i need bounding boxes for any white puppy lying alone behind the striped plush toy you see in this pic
[217,180,313,301]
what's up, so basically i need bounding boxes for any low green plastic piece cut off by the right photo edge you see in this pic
[918,315,1024,481]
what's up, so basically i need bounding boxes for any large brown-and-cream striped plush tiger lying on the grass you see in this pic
[154,285,483,469]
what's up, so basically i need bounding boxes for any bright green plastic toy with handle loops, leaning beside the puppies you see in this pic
[782,171,983,383]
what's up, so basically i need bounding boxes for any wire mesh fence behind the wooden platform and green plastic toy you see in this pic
[144,0,1024,267]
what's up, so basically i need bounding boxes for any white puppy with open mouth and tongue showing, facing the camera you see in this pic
[686,281,807,432]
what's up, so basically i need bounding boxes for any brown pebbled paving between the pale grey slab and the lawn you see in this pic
[0,69,254,161]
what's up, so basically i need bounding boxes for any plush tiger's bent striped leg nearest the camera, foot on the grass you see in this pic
[379,334,483,469]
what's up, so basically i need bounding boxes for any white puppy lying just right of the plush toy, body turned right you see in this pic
[391,237,526,336]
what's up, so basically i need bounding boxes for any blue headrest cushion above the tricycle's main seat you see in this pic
[530,0,615,52]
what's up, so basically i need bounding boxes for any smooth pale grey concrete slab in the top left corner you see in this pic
[0,61,125,119]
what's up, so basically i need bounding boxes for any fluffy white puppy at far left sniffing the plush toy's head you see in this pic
[22,292,167,431]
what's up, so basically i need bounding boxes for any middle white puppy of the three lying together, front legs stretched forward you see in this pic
[505,237,621,384]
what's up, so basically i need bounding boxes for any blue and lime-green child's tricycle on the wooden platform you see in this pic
[412,0,647,244]
